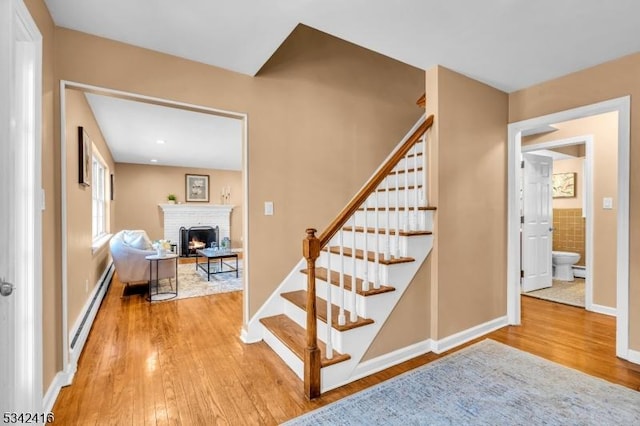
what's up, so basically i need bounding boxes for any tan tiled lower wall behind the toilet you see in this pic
[553,209,585,266]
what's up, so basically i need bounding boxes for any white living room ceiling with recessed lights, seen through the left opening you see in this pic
[85,93,242,170]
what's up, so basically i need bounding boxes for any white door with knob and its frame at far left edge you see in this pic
[0,0,42,414]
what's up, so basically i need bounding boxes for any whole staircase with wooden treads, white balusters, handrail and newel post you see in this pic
[245,111,435,398]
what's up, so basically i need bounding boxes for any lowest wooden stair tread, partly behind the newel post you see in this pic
[260,314,351,367]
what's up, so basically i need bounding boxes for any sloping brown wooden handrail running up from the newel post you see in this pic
[318,115,433,248]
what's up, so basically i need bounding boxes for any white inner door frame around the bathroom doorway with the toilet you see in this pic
[521,135,596,313]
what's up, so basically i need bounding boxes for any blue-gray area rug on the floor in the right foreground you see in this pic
[285,340,640,426]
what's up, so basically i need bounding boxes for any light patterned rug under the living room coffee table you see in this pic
[154,260,243,302]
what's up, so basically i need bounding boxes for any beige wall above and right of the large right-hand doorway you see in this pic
[509,53,640,351]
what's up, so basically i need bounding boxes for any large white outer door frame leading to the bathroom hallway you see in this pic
[507,96,631,359]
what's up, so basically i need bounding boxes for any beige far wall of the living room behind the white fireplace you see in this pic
[114,163,244,247]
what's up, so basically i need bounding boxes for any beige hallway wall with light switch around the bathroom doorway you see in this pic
[523,112,618,308]
